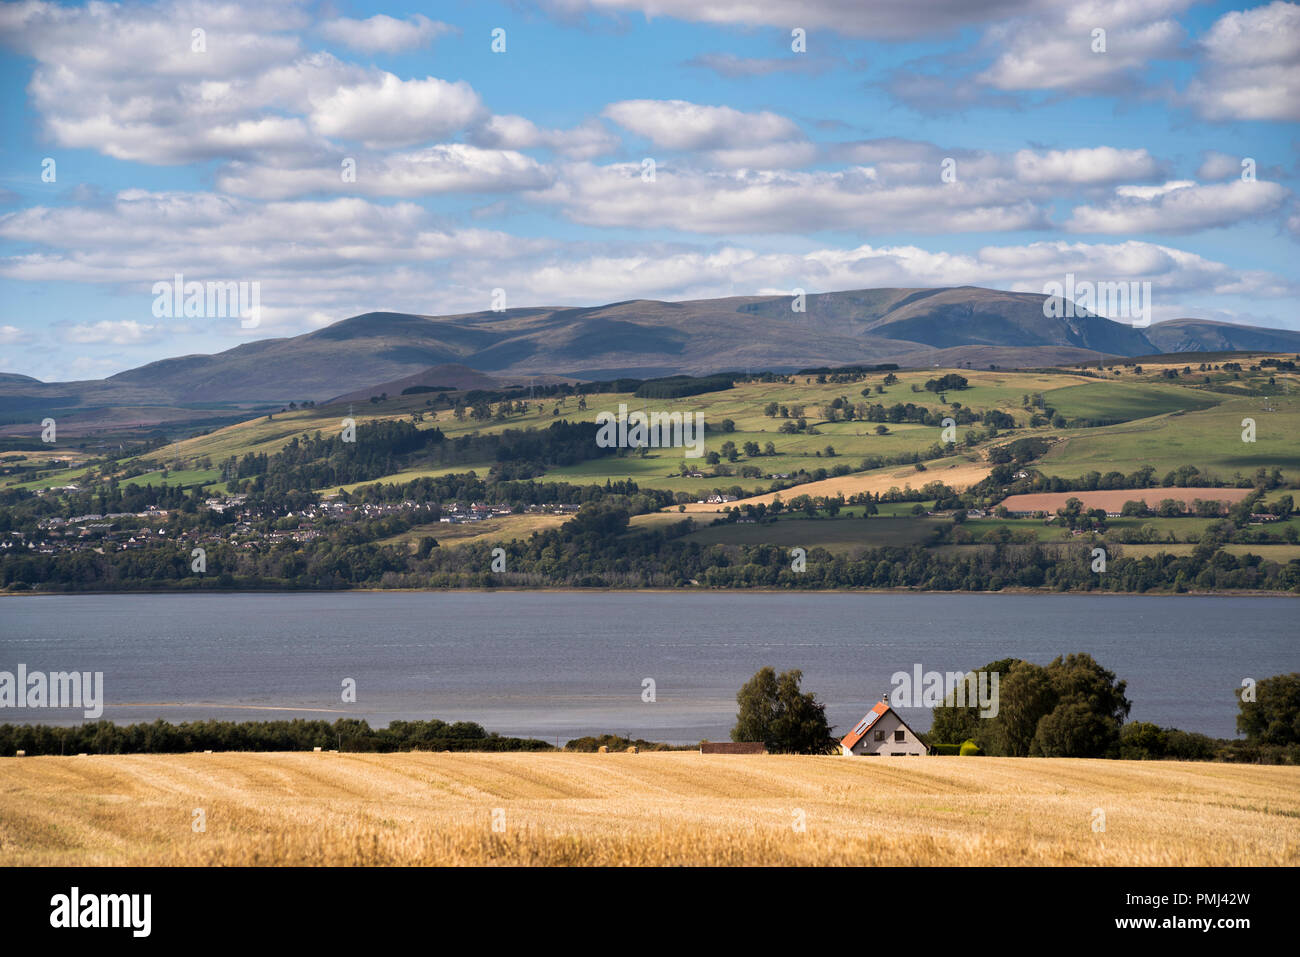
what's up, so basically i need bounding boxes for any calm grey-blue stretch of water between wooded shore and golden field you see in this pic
[0,592,1300,742]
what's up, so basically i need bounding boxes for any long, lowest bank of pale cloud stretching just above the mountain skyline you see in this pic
[0,190,1296,345]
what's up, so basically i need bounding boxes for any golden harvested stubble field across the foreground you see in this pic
[0,752,1300,866]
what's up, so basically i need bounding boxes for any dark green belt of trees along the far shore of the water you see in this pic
[10,503,1300,594]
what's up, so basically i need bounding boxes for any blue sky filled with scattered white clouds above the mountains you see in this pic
[0,0,1300,381]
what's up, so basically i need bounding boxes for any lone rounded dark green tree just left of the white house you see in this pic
[731,667,835,754]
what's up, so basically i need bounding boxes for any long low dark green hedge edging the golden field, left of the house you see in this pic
[0,718,554,757]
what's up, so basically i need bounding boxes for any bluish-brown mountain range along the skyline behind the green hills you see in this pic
[0,286,1300,434]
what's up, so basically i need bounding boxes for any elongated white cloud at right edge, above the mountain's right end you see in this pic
[1066,179,1291,233]
